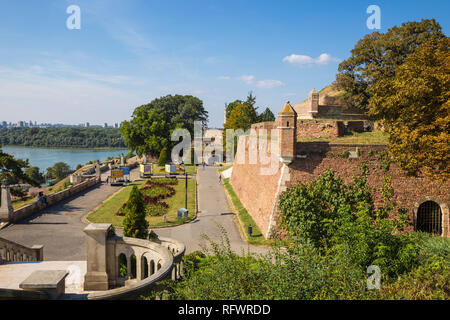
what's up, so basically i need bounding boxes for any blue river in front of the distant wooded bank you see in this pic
[1,146,128,172]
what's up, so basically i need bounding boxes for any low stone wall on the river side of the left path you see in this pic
[10,178,100,223]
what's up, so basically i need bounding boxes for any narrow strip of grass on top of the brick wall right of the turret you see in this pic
[297,131,389,144]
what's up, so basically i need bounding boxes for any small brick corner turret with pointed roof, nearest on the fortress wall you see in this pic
[277,101,297,165]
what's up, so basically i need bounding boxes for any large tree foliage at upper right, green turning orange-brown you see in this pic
[336,19,450,180]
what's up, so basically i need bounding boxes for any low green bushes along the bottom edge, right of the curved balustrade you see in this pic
[162,230,370,300]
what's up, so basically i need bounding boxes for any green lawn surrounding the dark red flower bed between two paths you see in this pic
[87,179,196,227]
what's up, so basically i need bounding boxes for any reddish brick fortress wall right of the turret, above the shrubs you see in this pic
[287,143,450,236]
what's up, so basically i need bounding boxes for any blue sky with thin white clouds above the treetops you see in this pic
[0,0,450,127]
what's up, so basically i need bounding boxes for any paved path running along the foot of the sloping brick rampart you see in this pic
[155,167,267,253]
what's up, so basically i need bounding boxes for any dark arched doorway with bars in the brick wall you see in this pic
[416,201,442,235]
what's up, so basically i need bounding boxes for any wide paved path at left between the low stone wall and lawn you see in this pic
[0,172,120,261]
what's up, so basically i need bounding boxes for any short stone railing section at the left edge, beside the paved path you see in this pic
[0,238,44,264]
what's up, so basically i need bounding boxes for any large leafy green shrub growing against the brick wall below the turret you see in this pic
[280,166,412,277]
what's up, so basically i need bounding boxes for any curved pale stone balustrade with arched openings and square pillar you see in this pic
[84,224,186,300]
